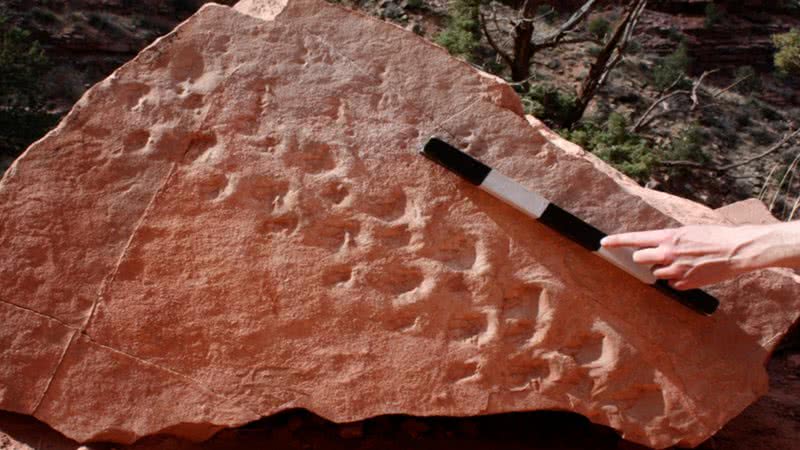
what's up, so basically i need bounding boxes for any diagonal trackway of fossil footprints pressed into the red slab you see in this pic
[111,26,615,406]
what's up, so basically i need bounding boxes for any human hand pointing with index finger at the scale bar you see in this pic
[601,225,765,290]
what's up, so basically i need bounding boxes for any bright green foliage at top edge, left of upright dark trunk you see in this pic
[436,0,480,59]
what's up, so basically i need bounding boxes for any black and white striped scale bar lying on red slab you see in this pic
[422,137,719,315]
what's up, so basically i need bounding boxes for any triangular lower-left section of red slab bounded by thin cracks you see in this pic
[35,336,258,444]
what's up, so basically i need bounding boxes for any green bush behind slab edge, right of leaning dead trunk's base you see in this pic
[562,113,660,182]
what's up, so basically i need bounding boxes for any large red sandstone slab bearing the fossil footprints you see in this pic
[0,0,800,447]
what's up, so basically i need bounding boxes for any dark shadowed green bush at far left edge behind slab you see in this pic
[0,16,58,164]
